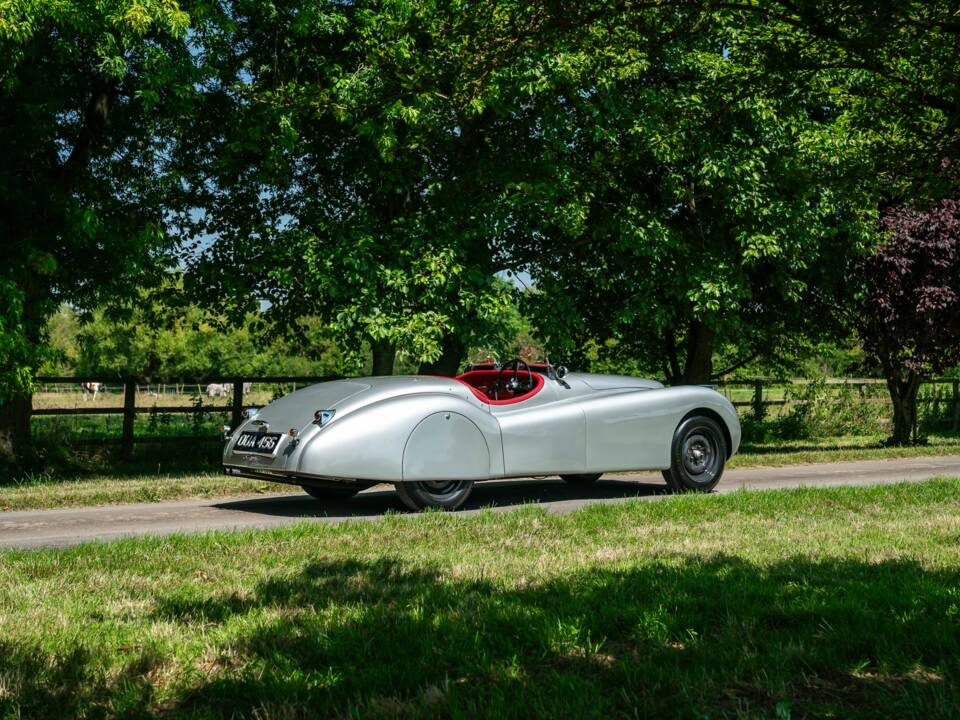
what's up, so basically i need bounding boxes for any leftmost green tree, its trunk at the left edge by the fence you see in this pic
[0,0,192,452]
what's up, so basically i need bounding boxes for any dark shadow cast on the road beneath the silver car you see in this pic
[213,477,666,518]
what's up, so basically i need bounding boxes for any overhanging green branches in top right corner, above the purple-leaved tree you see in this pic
[715,0,960,197]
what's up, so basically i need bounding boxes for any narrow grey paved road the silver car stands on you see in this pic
[0,455,960,548]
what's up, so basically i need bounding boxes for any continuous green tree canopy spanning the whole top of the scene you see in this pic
[0,0,960,456]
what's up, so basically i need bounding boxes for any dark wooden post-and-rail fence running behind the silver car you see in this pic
[33,375,960,455]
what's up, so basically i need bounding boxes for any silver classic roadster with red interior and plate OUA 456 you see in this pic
[223,359,740,509]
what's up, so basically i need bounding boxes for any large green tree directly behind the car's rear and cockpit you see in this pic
[183,2,677,373]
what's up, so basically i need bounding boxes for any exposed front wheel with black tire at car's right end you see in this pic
[663,415,727,492]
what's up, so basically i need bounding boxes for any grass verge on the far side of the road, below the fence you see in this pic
[0,435,960,511]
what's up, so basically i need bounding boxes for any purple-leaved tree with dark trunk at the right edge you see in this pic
[861,200,960,444]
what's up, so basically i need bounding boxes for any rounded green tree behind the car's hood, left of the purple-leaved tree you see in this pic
[516,4,876,383]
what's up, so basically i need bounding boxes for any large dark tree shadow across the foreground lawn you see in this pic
[0,556,960,718]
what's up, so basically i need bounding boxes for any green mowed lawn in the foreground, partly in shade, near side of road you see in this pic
[0,479,960,719]
